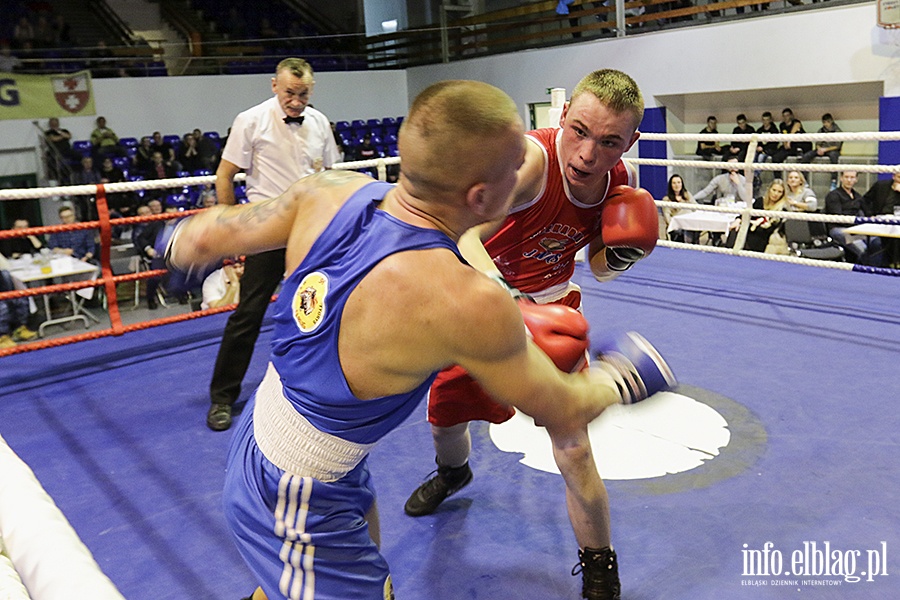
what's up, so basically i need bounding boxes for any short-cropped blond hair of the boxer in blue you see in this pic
[398,80,524,196]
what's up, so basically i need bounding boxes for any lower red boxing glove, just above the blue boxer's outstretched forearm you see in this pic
[518,301,590,373]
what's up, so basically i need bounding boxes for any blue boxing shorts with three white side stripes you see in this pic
[223,376,394,600]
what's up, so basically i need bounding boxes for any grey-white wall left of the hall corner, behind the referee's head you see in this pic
[0,71,408,175]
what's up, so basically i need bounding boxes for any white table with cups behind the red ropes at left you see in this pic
[9,254,100,337]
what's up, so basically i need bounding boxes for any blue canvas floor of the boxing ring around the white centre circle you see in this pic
[0,136,900,600]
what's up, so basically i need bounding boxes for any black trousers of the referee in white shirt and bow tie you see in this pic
[209,249,285,404]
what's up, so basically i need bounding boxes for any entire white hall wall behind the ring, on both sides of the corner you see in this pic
[0,2,900,175]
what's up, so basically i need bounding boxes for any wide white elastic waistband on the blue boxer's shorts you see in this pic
[253,363,374,481]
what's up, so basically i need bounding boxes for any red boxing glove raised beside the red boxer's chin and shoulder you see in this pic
[600,185,659,271]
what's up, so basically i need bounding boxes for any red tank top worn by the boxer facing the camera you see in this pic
[484,128,635,293]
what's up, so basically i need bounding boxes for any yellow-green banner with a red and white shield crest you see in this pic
[0,71,97,120]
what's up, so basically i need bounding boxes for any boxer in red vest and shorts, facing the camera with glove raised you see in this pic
[405,69,674,599]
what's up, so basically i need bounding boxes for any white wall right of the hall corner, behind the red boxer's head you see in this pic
[407,2,900,137]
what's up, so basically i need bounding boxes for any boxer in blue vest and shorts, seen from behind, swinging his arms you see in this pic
[166,81,667,600]
